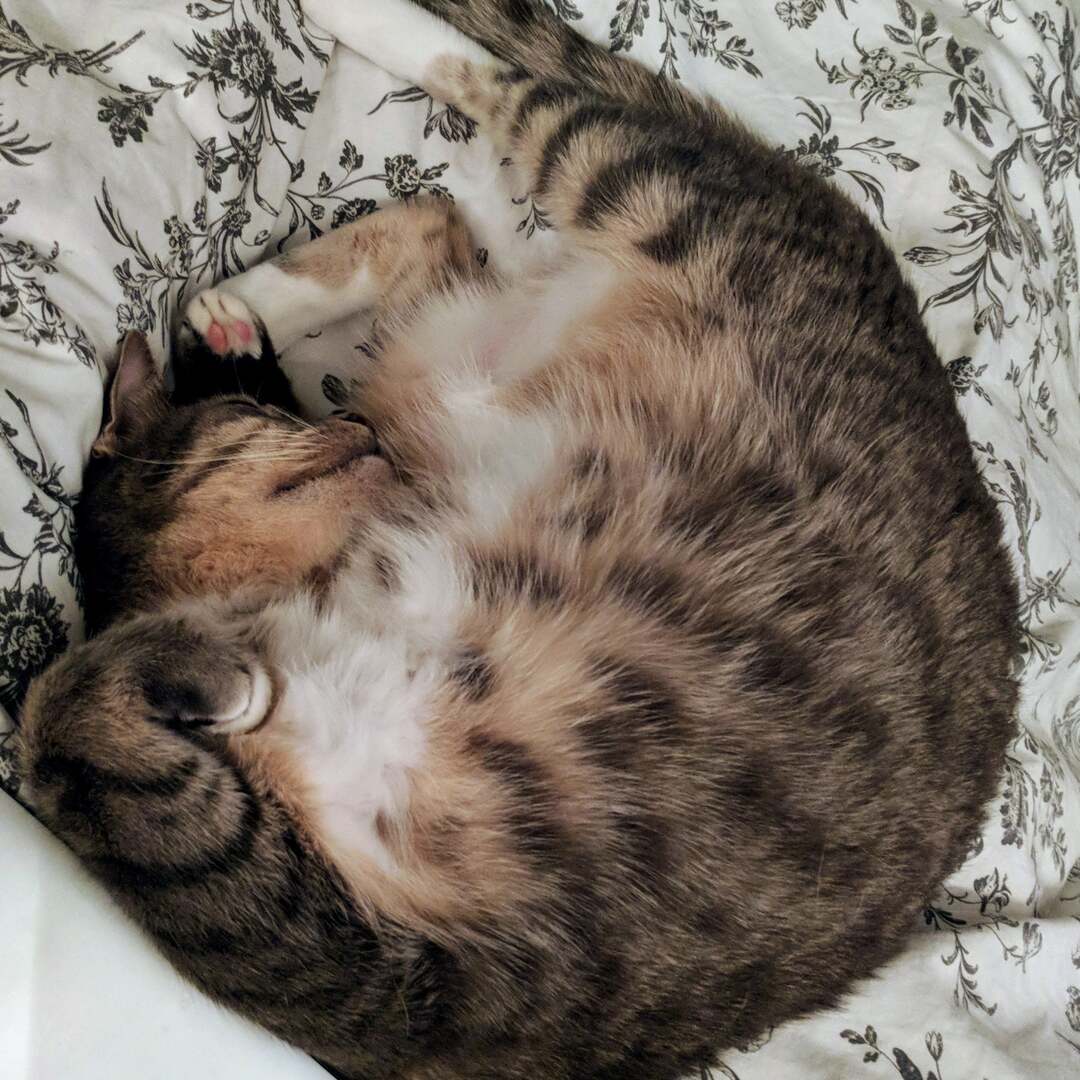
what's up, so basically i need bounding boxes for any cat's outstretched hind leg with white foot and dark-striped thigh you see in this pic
[303,0,708,266]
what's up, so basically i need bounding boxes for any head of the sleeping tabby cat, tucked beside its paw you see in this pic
[76,334,392,632]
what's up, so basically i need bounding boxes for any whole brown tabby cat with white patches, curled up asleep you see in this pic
[22,0,1017,1080]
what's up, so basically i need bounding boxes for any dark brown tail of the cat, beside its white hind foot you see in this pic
[414,0,719,121]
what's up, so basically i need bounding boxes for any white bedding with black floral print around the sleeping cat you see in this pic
[0,0,1080,1080]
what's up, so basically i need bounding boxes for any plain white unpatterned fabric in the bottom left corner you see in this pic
[0,795,326,1080]
